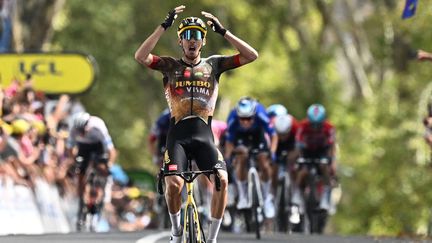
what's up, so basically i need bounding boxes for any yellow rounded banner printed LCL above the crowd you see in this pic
[0,53,97,94]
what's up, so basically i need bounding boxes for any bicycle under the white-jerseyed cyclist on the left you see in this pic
[76,156,107,232]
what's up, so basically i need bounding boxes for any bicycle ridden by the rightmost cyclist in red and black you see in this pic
[297,157,329,234]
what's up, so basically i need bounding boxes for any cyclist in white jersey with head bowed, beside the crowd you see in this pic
[66,112,116,230]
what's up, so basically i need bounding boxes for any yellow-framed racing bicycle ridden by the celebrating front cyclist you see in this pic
[157,160,221,243]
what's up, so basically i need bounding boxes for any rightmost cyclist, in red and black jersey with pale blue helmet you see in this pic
[292,104,336,214]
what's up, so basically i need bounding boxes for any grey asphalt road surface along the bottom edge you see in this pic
[0,230,426,243]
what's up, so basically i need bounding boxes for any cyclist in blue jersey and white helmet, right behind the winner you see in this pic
[225,97,278,218]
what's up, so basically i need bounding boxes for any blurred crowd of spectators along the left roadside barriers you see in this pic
[0,75,156,233]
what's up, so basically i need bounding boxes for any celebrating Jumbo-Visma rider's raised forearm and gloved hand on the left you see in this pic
[135,5,185,65]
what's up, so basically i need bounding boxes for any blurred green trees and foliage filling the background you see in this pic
[53,0,432,235]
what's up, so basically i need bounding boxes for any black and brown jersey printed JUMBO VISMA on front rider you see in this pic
[149,55,240,122]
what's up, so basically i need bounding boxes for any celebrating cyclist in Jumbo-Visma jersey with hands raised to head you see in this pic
[135,5,258,242]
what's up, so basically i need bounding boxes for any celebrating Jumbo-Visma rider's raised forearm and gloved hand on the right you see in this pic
[201,11,258,65]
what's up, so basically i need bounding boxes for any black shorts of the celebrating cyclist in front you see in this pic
[164,117,226,172]
